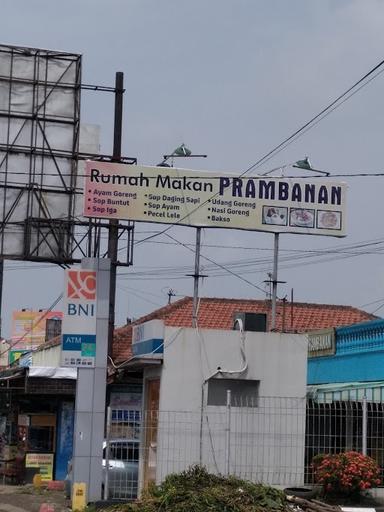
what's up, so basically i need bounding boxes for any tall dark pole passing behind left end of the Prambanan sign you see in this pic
[108,71,124,357]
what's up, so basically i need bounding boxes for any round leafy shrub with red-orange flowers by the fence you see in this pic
[312,451,381,497]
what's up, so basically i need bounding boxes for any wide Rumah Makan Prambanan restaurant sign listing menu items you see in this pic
[84,161,346,237]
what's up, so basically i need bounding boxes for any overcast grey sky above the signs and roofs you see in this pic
[0,0,384,336]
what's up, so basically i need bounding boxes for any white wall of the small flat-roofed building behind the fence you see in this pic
[145,327,307,485]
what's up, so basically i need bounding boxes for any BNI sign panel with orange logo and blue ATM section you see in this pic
[61,269,96,367]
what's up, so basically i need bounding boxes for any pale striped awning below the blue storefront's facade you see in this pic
[307,381,384,403]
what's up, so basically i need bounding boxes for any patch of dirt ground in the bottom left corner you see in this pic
[0,485,71,512]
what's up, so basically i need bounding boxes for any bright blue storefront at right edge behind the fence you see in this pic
[306,319,384,482]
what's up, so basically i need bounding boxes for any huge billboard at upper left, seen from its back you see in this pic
[0,44,81,262]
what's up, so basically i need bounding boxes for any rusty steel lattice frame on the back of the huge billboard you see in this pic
[0,45,136,266]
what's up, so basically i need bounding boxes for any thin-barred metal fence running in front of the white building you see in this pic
[107,397,384,499]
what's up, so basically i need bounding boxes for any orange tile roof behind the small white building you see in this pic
[113,297,377,362]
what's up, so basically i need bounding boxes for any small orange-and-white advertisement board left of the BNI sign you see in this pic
[11,310,63,350]
